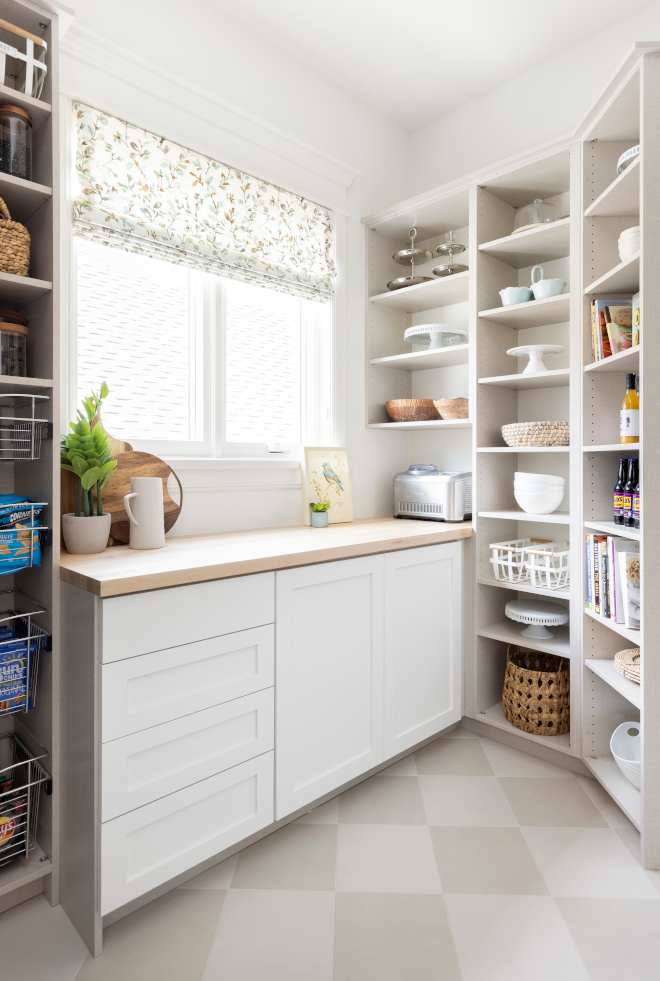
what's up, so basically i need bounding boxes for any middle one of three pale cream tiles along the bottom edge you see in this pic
[202,889,335,981]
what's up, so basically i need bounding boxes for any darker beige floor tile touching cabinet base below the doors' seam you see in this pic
[339,776,426,824]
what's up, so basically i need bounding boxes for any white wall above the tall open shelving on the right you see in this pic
[412,2,660,194]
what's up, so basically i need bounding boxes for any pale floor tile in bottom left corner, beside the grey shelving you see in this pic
[0,896,88,981]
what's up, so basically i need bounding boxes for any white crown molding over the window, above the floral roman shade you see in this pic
[60,22,360,189]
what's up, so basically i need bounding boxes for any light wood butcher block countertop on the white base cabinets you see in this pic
[60,518,472,597]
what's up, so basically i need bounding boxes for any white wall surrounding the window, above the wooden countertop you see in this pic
[62,0,410,534]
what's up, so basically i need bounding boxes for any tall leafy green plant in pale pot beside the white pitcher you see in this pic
[60,382,117,555]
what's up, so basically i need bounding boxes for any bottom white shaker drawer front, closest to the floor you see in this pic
[100,752,273,916]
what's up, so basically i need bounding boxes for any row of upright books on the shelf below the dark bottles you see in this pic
[585,534,640,630]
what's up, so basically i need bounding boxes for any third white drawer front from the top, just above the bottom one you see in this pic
[101,688,275,821]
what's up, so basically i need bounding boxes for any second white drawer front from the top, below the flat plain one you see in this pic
[101,625,274,743]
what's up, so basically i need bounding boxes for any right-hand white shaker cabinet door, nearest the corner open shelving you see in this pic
[384,542,462,759]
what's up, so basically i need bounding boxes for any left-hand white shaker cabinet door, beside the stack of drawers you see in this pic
[275,556,383,819]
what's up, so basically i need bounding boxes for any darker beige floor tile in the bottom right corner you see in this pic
[556,898,660,981]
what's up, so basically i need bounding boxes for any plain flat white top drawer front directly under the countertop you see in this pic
[101,572,275,662]
